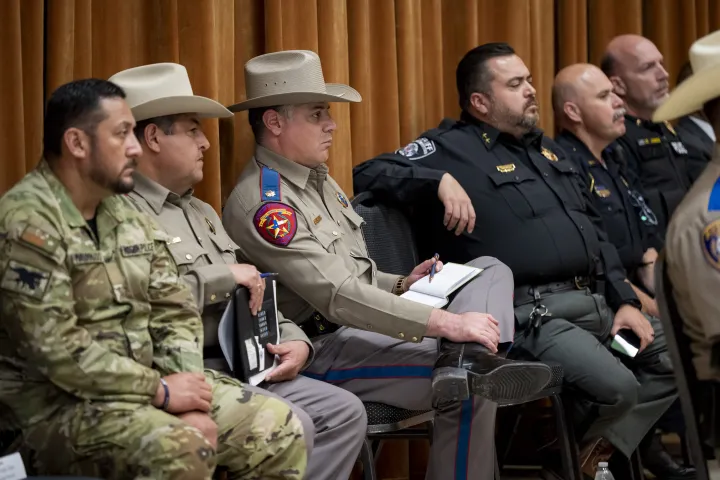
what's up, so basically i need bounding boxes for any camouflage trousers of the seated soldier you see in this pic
[22,370,311,480]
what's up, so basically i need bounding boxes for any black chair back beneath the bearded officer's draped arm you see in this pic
[352,192,420,275]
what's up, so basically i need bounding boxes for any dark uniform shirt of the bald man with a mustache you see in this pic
[555,131,662,274]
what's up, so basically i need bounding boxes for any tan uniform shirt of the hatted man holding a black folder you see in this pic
[130,173,312,352]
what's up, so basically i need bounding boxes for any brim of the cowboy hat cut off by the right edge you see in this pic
[652,64,720,122]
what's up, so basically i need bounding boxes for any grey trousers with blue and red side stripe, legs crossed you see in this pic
[304,257,514,480]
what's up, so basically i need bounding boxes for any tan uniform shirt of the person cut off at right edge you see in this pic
[665,145,720,380]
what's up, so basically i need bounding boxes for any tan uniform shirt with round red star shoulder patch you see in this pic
[223,146,432,342]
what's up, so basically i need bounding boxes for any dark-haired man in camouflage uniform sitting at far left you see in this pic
[0,79,311,479]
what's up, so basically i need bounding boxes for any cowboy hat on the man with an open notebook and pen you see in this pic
[229,50,362,112]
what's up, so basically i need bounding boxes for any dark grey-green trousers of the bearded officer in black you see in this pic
[510,289,677,457]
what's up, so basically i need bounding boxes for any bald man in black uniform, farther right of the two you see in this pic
[601,35,692,234]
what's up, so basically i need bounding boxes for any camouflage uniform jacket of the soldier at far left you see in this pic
[0,161,203,428]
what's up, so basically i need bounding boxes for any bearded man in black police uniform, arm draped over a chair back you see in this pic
[354,43,677,478]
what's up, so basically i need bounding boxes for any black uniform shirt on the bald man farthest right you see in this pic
[617,115,692,232]
